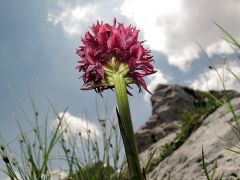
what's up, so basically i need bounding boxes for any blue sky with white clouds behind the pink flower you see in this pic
[0,0,240,177]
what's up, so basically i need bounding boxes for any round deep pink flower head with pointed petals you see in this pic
[76,19,156,93]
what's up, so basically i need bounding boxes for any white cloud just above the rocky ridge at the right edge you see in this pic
[190,63,240,91]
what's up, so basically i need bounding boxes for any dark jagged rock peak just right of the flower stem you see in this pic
[136,85,195,152]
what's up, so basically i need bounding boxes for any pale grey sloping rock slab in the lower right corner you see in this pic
[146,98,240,180]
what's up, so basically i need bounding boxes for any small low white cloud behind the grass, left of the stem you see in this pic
[55,112,100,139]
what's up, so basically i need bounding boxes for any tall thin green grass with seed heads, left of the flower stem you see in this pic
[0,94,126,180]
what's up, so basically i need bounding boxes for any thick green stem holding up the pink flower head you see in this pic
[113,73,143,180]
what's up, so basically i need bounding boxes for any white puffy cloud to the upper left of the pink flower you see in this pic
[48,3,97,36]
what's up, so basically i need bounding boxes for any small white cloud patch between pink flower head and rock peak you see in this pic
[144,69,171,101]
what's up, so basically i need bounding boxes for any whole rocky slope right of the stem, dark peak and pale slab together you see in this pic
[136,85,240,180]
